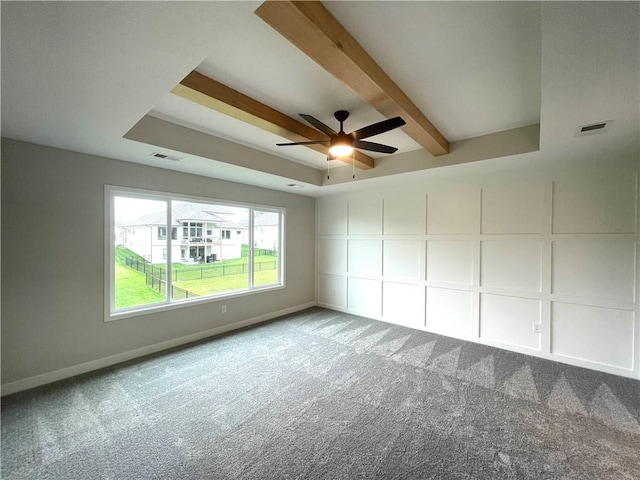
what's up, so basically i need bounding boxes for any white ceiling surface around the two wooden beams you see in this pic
[1,1,640,196]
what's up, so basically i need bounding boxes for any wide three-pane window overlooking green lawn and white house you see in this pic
[105,187,284,319]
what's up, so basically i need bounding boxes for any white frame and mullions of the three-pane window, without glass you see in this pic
[103,185,286,322]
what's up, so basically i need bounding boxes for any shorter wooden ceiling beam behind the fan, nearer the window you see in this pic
[171,70,375,170]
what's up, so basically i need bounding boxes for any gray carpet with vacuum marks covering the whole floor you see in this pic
[2,308,640,480]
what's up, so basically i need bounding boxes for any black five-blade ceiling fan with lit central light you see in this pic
[276,110,406,157]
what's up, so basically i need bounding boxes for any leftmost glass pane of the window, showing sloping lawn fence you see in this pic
[113,195,167,309]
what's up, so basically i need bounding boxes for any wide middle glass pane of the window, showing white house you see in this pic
[171,201,249,300]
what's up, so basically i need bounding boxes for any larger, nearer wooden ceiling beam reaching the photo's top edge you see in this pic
[255,0,449,155]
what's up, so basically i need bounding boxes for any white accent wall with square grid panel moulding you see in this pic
[317,162,640,378]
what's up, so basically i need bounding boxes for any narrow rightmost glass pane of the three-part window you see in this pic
[253,210,280,286]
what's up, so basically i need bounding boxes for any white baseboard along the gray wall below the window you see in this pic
[0,302,316,396]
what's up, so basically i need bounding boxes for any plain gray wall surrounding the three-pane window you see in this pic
[2,139,315,394]
